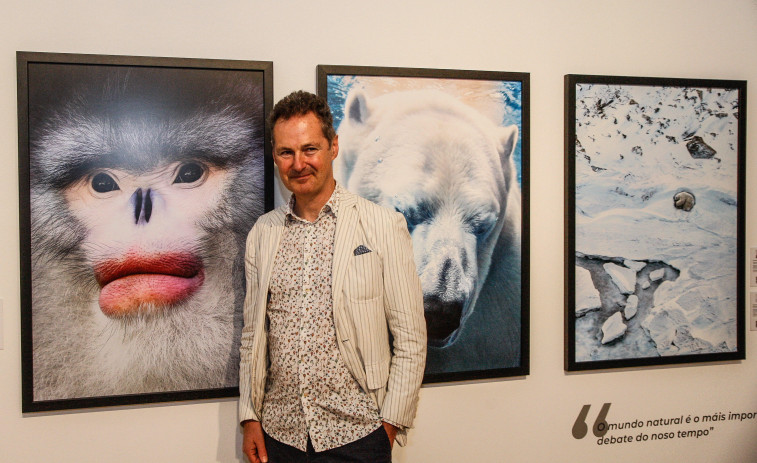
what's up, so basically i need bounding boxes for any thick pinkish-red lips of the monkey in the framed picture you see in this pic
[95,252,205,317]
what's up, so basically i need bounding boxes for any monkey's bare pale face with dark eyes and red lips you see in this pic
[64,160,228,318]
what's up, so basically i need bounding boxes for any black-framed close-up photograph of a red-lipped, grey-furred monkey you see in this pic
[17,52,273,412]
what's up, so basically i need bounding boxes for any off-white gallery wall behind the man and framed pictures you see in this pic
[0,0,757,463]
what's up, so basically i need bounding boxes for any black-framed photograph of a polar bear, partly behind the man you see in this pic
[317,65,529,383]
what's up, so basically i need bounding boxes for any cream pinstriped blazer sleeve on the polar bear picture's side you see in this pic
[380,211,426,440]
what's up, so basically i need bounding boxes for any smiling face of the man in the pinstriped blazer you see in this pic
[273,112,339,202]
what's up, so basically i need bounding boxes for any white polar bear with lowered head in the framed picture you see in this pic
[334,89,521,347]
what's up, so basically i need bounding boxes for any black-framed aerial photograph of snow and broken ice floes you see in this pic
[565,75,746,370]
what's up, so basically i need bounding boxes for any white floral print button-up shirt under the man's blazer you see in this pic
[262,185,381,452]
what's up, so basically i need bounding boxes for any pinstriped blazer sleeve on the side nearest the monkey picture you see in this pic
[239,227,260,422]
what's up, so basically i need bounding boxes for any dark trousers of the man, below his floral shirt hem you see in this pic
[263,426,392,463]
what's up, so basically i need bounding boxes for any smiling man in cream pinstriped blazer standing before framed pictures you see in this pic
[239,91,426,463]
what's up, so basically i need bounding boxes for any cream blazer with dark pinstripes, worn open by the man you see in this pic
[239,191,426,445]
